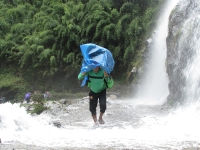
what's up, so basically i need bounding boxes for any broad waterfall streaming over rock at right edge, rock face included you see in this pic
[167,0,200,104]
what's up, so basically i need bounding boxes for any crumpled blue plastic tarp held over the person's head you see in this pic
[80,43,115,86]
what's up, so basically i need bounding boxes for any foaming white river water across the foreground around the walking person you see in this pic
[0,100,200,149]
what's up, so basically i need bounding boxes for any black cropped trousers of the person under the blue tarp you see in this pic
[89,89,106,116]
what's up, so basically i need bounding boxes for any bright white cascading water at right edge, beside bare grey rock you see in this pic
[180,15,200,103]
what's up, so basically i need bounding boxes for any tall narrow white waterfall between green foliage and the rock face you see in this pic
[135,0,179,105]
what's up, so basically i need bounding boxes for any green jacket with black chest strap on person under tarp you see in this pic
[78,69,114,93]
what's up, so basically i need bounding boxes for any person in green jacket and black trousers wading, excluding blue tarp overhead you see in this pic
[78,67,113,124]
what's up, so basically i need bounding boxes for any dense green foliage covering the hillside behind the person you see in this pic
[0,0,164,99]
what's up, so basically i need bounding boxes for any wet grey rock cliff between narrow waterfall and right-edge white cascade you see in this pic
[167,0,200,103]
